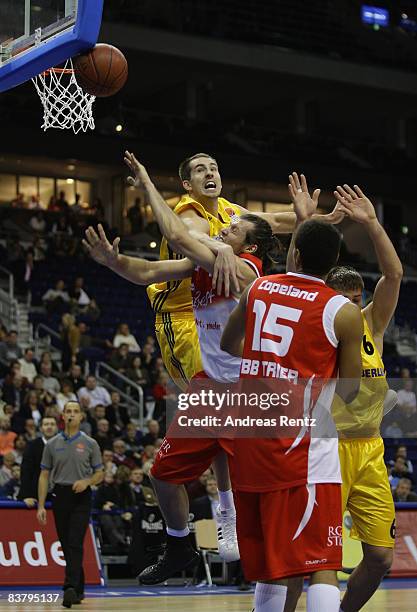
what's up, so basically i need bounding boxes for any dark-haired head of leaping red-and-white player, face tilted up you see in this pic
[218,213,282,273]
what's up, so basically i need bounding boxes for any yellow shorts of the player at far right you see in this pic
[339,437,395,548]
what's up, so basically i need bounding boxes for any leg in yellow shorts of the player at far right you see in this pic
[341,438,395,612]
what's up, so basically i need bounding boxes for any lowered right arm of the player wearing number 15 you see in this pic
[334,303,363,404]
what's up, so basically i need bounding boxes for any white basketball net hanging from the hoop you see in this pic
[32,59,96,134]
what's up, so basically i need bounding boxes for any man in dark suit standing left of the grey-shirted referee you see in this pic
[19,416,58,508]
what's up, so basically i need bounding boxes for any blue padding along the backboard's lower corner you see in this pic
[0,0,104,92]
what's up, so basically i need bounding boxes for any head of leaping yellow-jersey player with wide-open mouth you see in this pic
[178,153,222,200]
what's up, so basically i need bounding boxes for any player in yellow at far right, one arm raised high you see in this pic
[326,185,403,612]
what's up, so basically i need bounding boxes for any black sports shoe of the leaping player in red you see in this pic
[138,536,200,585]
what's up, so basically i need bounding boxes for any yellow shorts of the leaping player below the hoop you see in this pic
[155,312,203,391]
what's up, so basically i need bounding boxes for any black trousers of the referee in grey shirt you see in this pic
[52,485,91,595]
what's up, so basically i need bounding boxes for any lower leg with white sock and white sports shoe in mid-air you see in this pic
[212,450,240,563]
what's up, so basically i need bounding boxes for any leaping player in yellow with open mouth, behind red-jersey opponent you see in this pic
[138,153,295,390]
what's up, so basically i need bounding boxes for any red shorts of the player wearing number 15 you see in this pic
[234,484,342,581]
